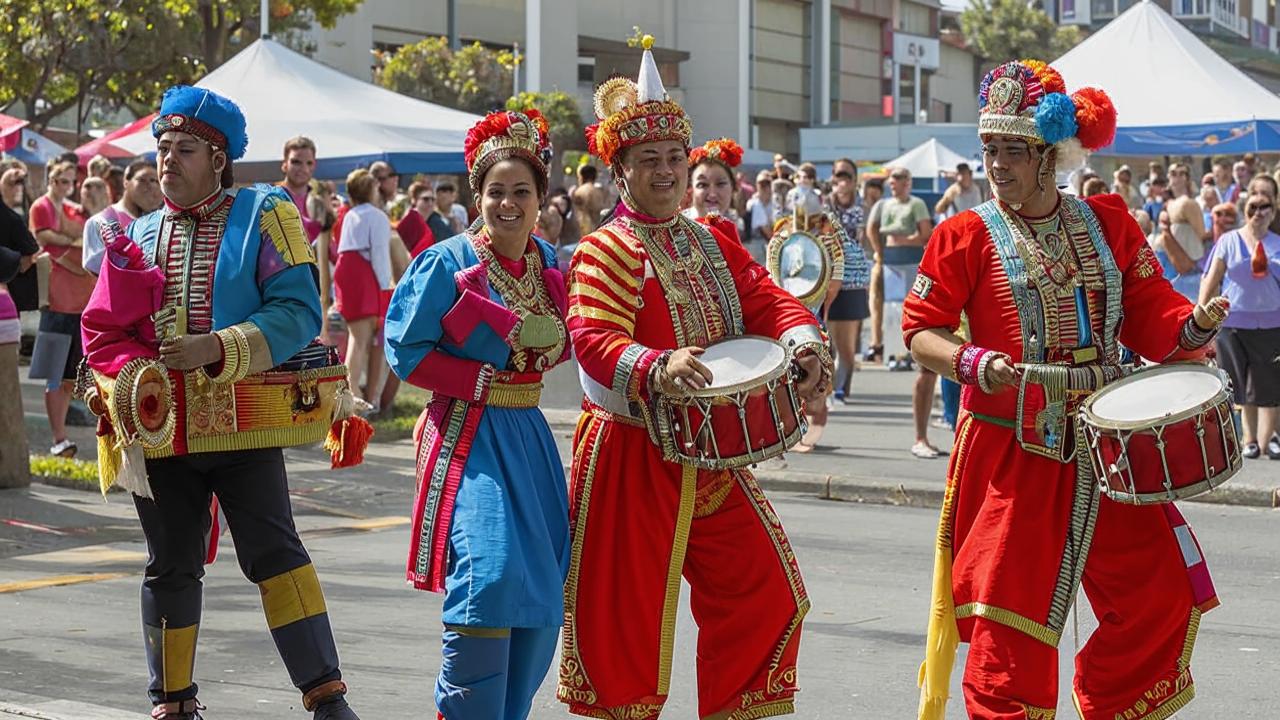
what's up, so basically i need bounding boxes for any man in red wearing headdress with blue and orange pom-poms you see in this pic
[902,60,1225,720]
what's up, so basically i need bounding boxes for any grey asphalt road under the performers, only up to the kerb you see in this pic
[0,481,1280,720]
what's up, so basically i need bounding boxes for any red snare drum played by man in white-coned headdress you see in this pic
[654,336,808,470]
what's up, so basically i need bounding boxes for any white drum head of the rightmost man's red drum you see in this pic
[1091,368,1222,423]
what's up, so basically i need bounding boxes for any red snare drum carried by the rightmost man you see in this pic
[1080,365,1242,505]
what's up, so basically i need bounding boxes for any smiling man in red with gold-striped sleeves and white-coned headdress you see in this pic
[558,36,831,720]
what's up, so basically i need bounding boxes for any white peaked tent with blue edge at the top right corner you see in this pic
[1052,0,1280,155]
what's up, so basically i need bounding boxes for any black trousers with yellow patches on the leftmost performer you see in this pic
[133,448,342,703]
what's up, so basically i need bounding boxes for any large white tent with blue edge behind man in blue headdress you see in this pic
[104,38,480,181]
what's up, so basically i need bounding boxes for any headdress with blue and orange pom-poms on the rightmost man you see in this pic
[978,60,1116,150]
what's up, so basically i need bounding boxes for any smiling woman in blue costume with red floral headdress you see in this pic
[387,110,570,720]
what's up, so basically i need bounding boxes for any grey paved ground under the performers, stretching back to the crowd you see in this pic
[10,307,1280,720]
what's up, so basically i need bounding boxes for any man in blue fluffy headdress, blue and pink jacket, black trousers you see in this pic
[83,86,367,720]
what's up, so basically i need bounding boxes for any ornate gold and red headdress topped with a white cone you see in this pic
[586,31,694,167]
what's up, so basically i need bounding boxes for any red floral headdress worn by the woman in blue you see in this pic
[462,108,552,194]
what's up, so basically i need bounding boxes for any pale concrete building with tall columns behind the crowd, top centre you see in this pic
[311,0,967,158]
